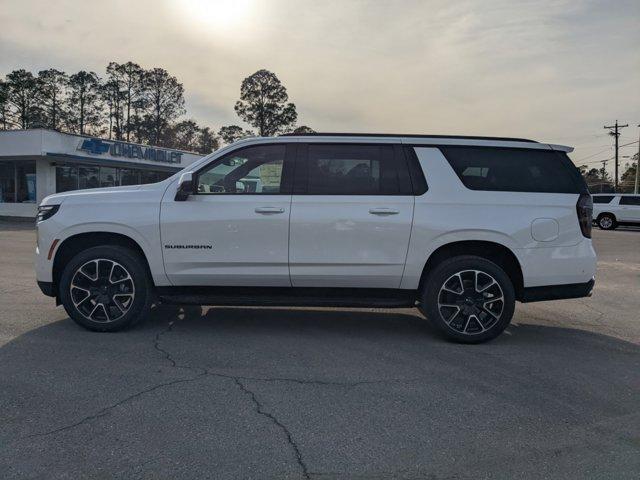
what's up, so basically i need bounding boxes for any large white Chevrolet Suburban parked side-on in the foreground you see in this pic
[36,134,596,342]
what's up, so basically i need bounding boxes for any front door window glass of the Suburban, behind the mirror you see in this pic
[197,145,286,195]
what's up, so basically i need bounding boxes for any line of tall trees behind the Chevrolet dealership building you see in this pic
[0,62,313,154]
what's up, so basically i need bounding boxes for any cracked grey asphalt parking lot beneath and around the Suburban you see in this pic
[0,223,640,480]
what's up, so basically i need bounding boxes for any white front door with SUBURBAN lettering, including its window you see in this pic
[160,143,293,286]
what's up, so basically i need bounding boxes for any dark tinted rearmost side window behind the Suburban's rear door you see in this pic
[440,147,587,193]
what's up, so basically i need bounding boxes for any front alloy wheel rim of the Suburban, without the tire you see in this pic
[69,258,135,323]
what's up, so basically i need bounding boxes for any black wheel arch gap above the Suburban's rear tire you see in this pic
[418,240,524,300]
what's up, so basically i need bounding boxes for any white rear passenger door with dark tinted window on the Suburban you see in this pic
[289,143,414,288]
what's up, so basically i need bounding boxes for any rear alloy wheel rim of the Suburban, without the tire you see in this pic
[438,270,504,335]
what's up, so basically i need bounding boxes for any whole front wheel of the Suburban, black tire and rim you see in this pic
[58,245,152,332]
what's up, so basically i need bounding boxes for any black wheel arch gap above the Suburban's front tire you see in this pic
[52,231,153,296]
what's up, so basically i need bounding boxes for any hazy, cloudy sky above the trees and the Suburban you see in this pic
[0,0,640,170]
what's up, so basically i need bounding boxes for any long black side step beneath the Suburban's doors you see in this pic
[157,286,417,308]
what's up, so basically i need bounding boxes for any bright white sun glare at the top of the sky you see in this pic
[171,0,252,30]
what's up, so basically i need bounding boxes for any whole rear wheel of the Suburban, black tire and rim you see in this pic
[420,255,515,343]
